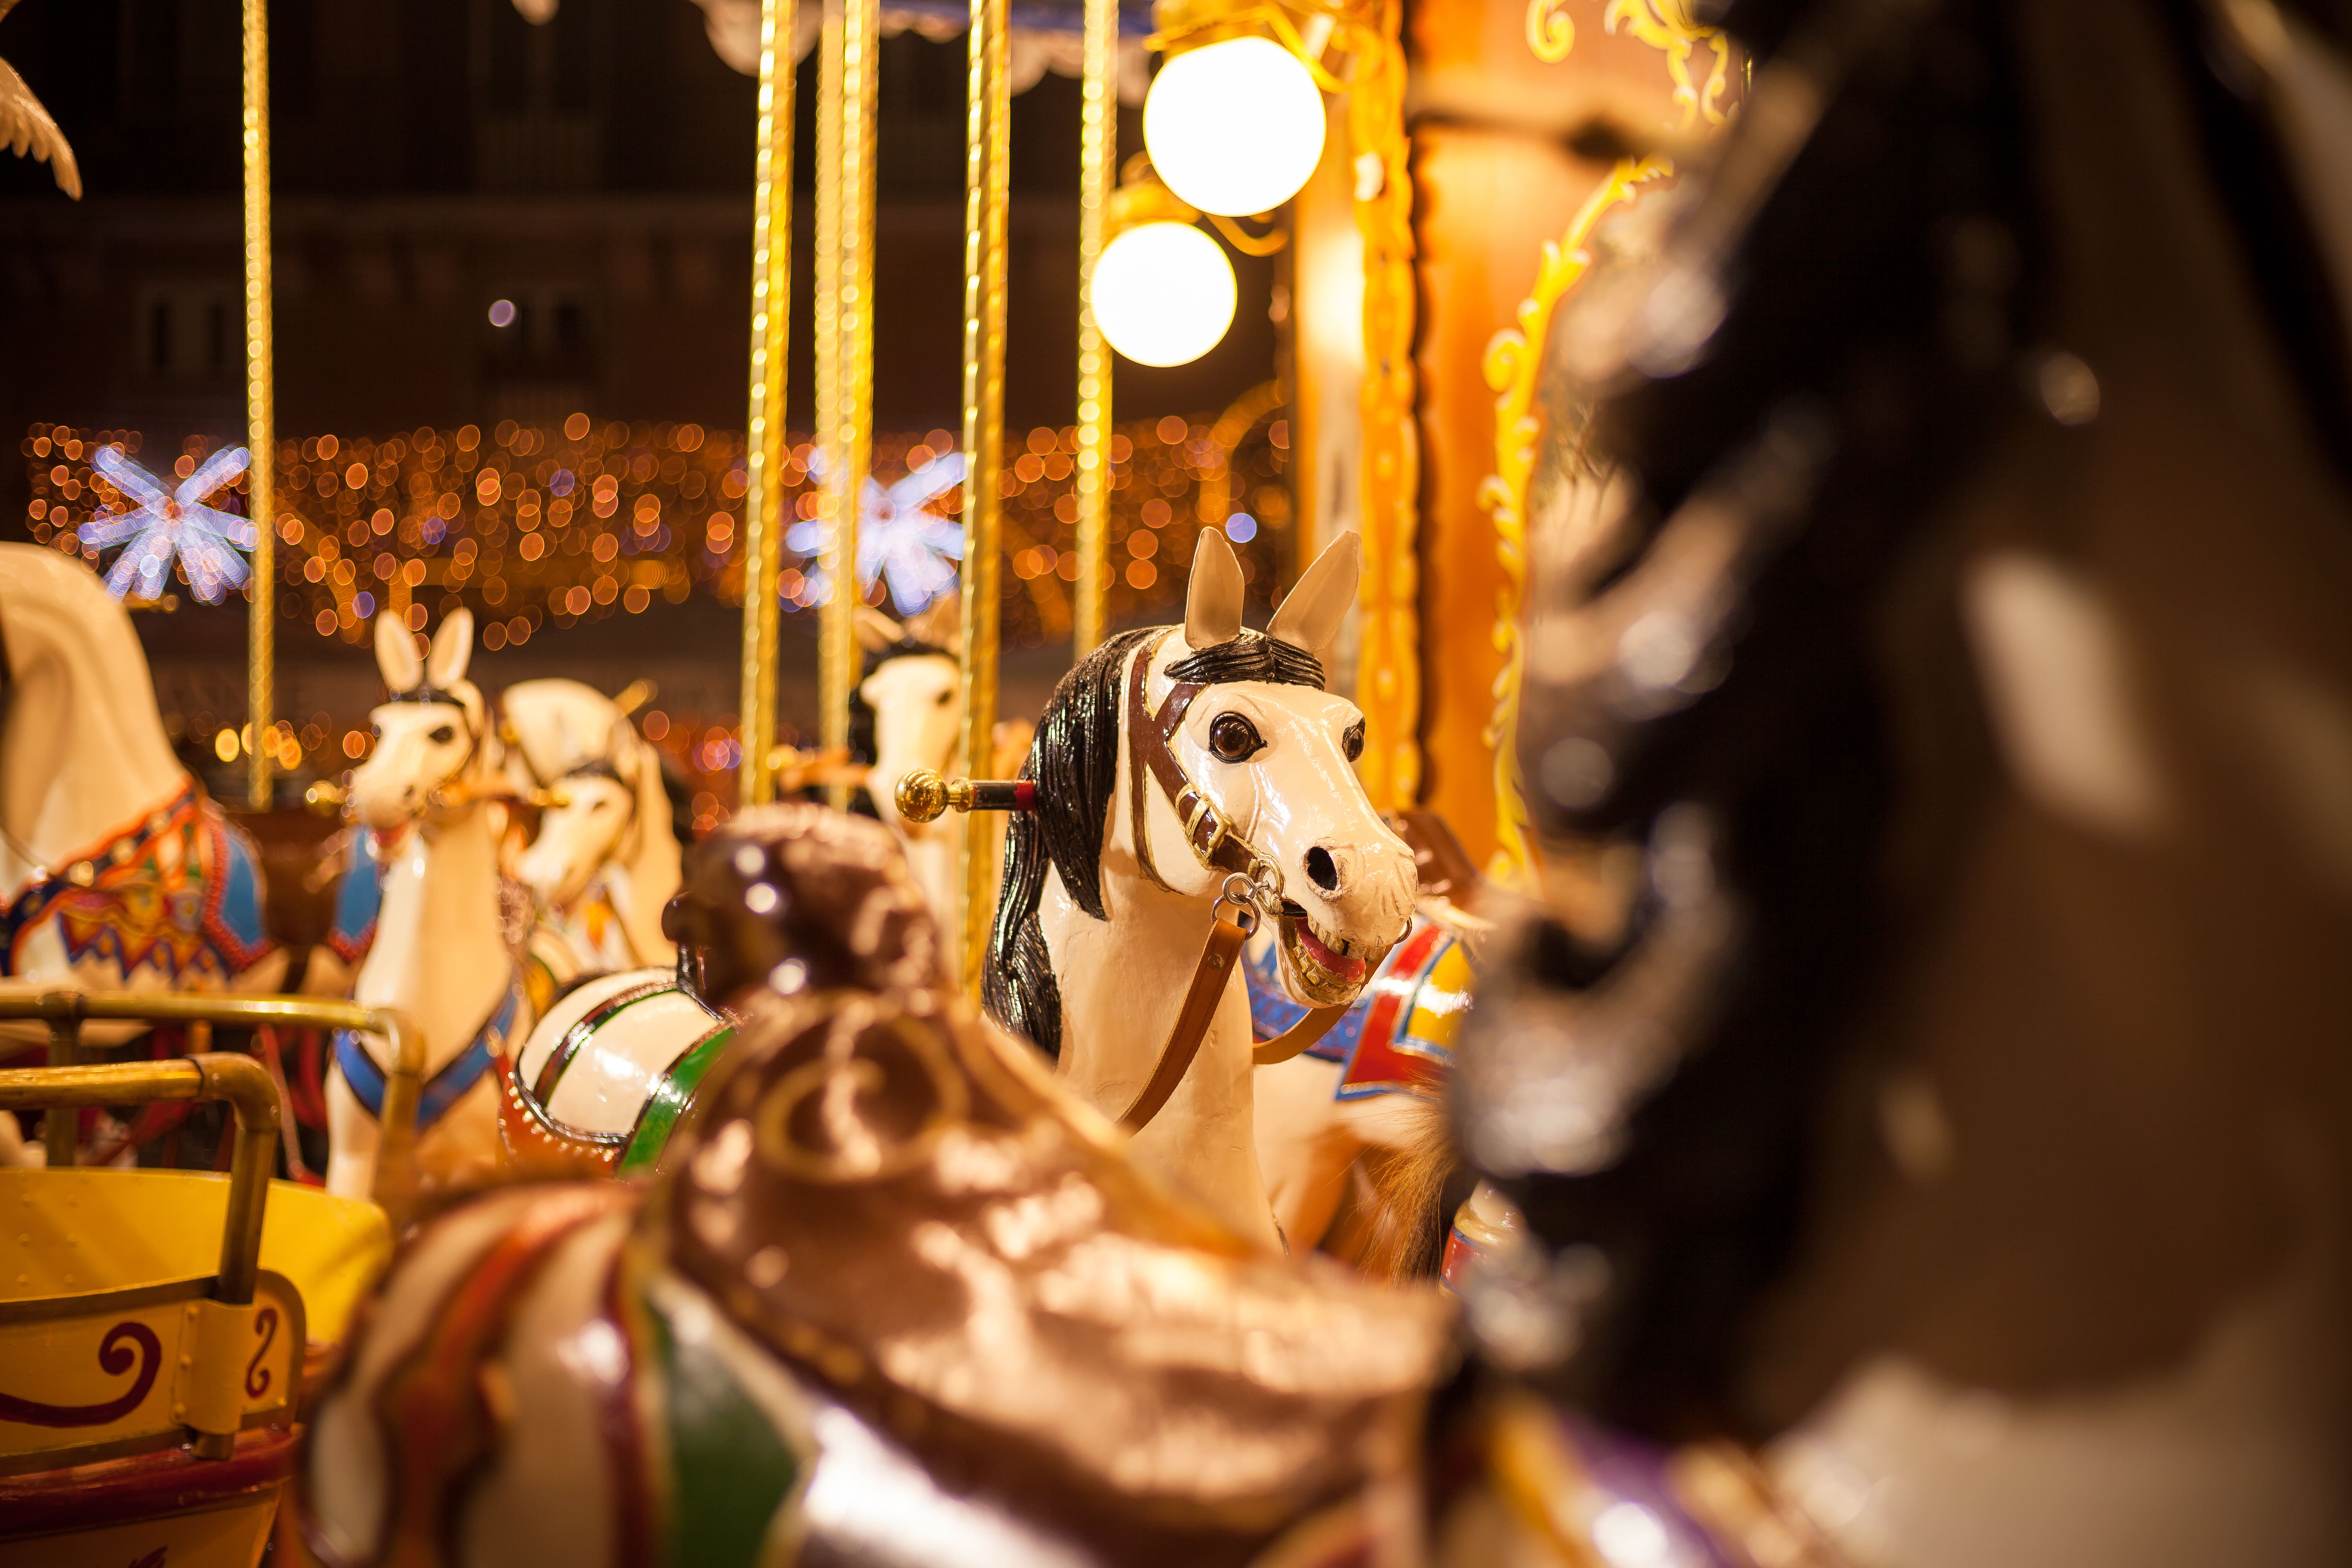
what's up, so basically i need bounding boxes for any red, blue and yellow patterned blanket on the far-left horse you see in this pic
[0,778,275,990]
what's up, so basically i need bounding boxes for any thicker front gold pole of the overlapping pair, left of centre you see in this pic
[816,0,882,806]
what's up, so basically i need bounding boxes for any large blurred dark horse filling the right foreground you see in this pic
[1437,0,2352,1568]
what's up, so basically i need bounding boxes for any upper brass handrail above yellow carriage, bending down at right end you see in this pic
[0,990,426,1227]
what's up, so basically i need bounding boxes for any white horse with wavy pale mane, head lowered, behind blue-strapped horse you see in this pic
[499,679,677,973]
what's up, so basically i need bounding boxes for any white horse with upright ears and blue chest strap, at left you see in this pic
[327,609,534,1197]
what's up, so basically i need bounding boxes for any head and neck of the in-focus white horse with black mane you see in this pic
[985,529,1416,1243]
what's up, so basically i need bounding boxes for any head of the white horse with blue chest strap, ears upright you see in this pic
[351,609,487,839]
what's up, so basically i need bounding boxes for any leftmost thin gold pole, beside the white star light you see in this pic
[245,0,278,811]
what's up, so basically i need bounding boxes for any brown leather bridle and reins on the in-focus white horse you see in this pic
[1119,628,1352,1133]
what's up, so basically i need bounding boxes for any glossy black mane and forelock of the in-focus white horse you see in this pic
[981,628,1324,1055]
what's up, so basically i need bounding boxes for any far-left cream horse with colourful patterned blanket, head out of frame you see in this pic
[0,543,287,1048]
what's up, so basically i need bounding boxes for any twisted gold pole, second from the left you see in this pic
[741,0,793,806]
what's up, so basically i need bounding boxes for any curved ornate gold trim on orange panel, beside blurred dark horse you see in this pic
[1477,157,1675,889]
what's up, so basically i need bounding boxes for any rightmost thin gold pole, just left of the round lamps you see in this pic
[1070,0,1119,658]
